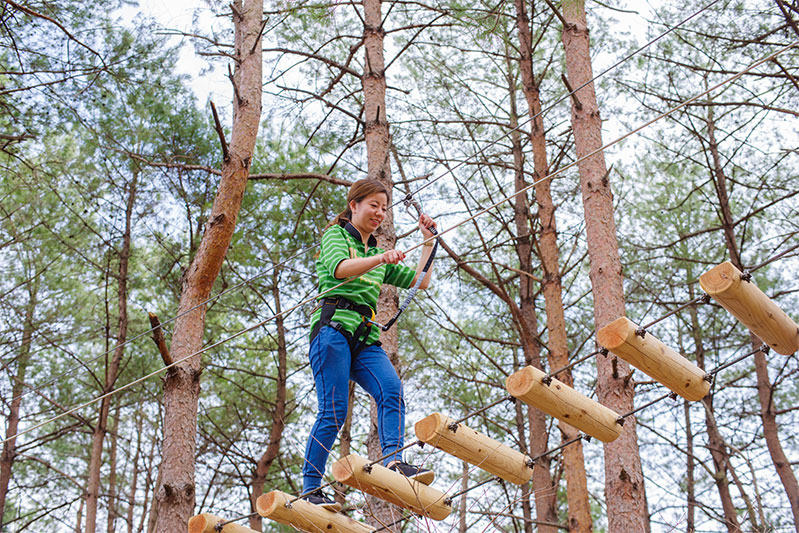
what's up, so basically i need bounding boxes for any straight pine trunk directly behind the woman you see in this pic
[361,0,404,531]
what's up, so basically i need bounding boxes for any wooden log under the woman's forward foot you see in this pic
[332,453,452,520]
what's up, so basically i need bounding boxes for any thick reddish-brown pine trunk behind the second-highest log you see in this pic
[562,0,650,533]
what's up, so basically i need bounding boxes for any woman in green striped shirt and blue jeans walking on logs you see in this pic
[302,179,436,511]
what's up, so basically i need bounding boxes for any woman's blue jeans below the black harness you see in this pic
[302,326,405,493]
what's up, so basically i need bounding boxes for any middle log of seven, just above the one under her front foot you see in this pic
[414,413,533,485]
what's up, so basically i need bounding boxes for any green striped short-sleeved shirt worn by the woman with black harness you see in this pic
[311,223,416,344]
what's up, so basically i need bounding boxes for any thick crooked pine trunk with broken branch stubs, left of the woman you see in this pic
[156,0,263,533]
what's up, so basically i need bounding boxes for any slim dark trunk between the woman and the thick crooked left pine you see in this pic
[250,268,288,531]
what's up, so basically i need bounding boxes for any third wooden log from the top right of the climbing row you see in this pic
[505,366,621,442]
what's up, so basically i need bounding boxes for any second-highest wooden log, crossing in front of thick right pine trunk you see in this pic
[597,317,710,402]
